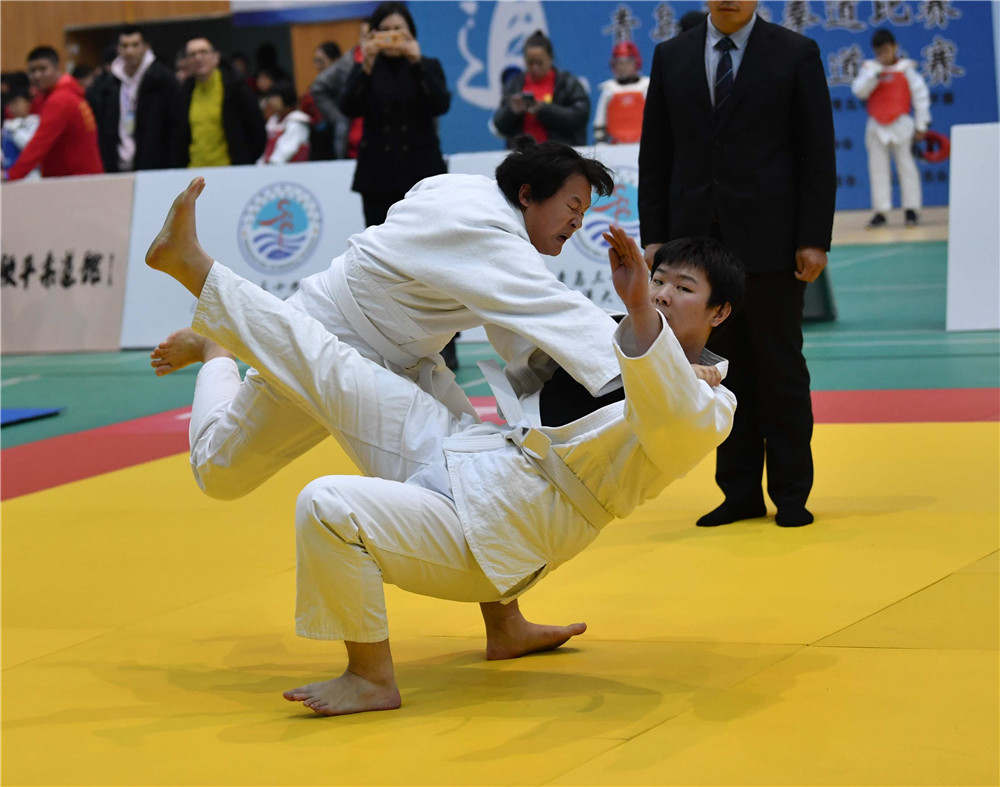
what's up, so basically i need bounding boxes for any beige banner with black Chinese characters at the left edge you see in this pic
[0,175,134,353]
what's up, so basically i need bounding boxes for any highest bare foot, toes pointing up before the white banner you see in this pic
[146,177,212,298]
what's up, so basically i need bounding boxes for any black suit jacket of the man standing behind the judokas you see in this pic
[639,18,836,273]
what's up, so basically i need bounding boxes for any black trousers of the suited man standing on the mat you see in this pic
[709,272,813,508]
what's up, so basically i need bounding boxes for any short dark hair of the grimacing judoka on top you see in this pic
[496,136,615,207]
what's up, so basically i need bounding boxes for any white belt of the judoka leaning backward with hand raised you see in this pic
[478,361,615,530]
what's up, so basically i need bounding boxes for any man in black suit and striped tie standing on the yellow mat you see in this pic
[639,0,836,527]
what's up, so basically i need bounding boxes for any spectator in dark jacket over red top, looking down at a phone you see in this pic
[493,30,590,147]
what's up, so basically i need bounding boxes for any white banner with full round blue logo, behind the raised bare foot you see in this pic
[121,161,365,348]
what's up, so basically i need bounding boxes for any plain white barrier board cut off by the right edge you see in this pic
[945,123,1000,331]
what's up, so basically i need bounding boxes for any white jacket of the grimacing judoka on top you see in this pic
[303,175,619,411]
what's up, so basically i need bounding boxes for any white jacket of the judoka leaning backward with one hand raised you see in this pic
[444,317,736,600]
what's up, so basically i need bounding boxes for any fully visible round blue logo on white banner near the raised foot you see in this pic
[237,183,323,274]
